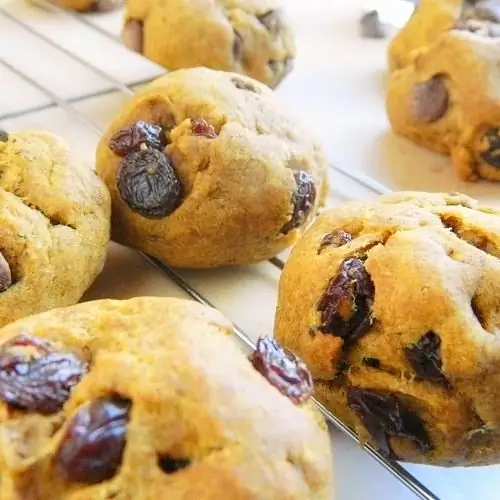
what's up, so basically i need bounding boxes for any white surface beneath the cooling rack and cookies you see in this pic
[0,0,500,500]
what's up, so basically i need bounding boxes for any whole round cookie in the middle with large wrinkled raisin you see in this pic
[97,68,328,268]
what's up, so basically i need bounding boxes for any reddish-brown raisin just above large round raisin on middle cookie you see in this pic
[109,121,166,156]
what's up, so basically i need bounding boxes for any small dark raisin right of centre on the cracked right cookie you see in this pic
[405,332,448,384]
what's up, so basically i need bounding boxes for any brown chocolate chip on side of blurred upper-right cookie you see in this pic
[412,75,449,124]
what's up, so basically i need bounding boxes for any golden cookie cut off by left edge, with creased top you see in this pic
[0,131,111,326]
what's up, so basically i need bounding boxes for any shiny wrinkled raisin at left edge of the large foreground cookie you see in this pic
[0,335,88,414]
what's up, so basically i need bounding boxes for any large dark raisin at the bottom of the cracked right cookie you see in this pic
[347,387,432,459]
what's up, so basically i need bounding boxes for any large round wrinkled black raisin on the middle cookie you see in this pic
[117,149,182,219]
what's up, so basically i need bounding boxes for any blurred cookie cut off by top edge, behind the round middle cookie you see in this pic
[123,0,295,87]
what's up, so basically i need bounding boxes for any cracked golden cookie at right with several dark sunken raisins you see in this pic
[275,192,500,466]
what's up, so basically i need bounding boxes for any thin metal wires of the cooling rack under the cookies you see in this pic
[0,0,439,500]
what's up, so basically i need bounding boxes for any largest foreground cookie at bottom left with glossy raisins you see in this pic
[0,297,332,500]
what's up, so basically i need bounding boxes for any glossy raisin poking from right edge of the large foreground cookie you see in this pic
[250,337,313,404]
